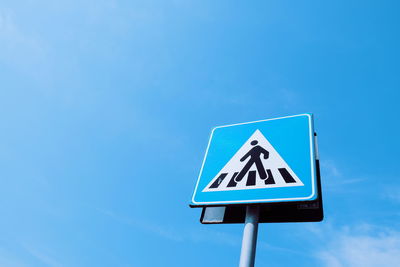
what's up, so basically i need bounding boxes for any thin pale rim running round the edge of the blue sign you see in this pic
[190,113,317,207]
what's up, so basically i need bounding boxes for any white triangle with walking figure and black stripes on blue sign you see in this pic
[203,130,304,192]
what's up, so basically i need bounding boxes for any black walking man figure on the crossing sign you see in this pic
[235,140,269,183]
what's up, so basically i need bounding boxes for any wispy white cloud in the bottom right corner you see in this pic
[309,224,400,267]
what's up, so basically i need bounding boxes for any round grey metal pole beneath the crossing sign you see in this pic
[239,206,260,267]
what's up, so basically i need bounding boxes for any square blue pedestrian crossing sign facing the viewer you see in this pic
[190,114,318,207]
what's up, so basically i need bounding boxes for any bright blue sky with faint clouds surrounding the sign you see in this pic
[0,0,400,267]
